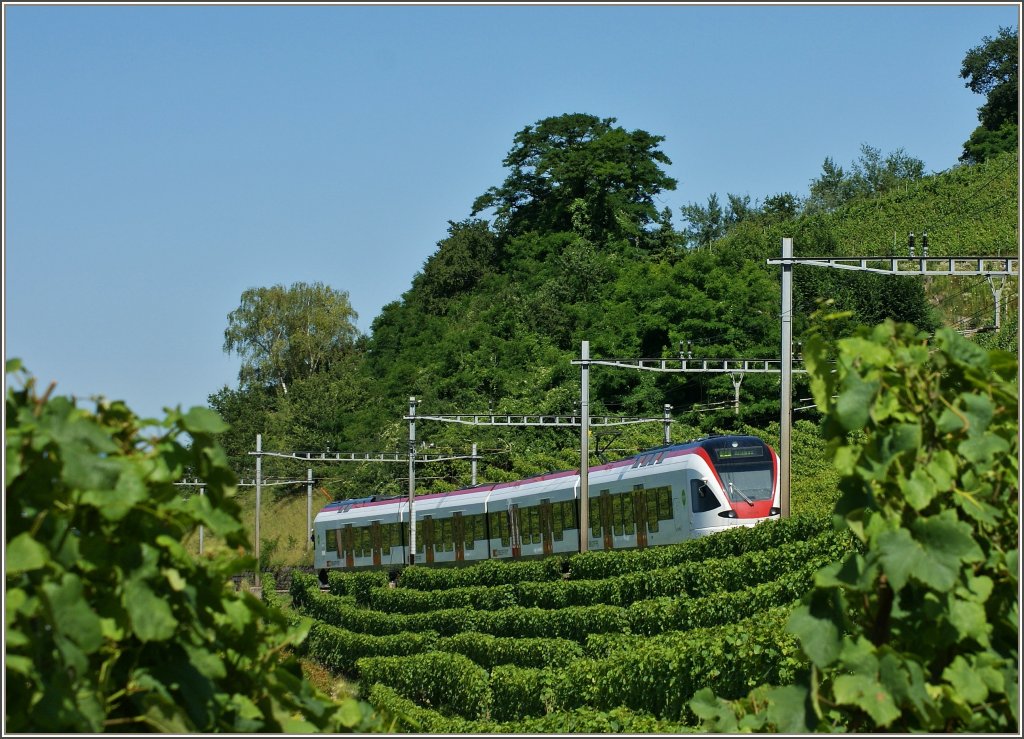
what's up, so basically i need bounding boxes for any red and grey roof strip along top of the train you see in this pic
[317,434,764,516]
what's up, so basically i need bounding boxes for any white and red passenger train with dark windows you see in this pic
[311,435,781,583]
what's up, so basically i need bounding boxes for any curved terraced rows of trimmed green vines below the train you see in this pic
[280,514,852,733]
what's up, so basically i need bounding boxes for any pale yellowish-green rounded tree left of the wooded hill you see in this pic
[224,282,358,393]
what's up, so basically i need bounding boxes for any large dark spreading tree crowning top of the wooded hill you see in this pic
[471,114,676,244]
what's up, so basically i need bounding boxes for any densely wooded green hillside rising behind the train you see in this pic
[211,114,1019,503]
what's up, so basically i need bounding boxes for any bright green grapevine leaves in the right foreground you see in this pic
[690,322,1020,733]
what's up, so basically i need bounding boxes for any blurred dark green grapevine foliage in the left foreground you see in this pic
[4,360,380,733]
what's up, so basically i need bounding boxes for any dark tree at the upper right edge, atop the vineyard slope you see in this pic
[961,28,1019,163]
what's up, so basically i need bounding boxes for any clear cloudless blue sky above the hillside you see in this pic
[3,3,1020,416]
